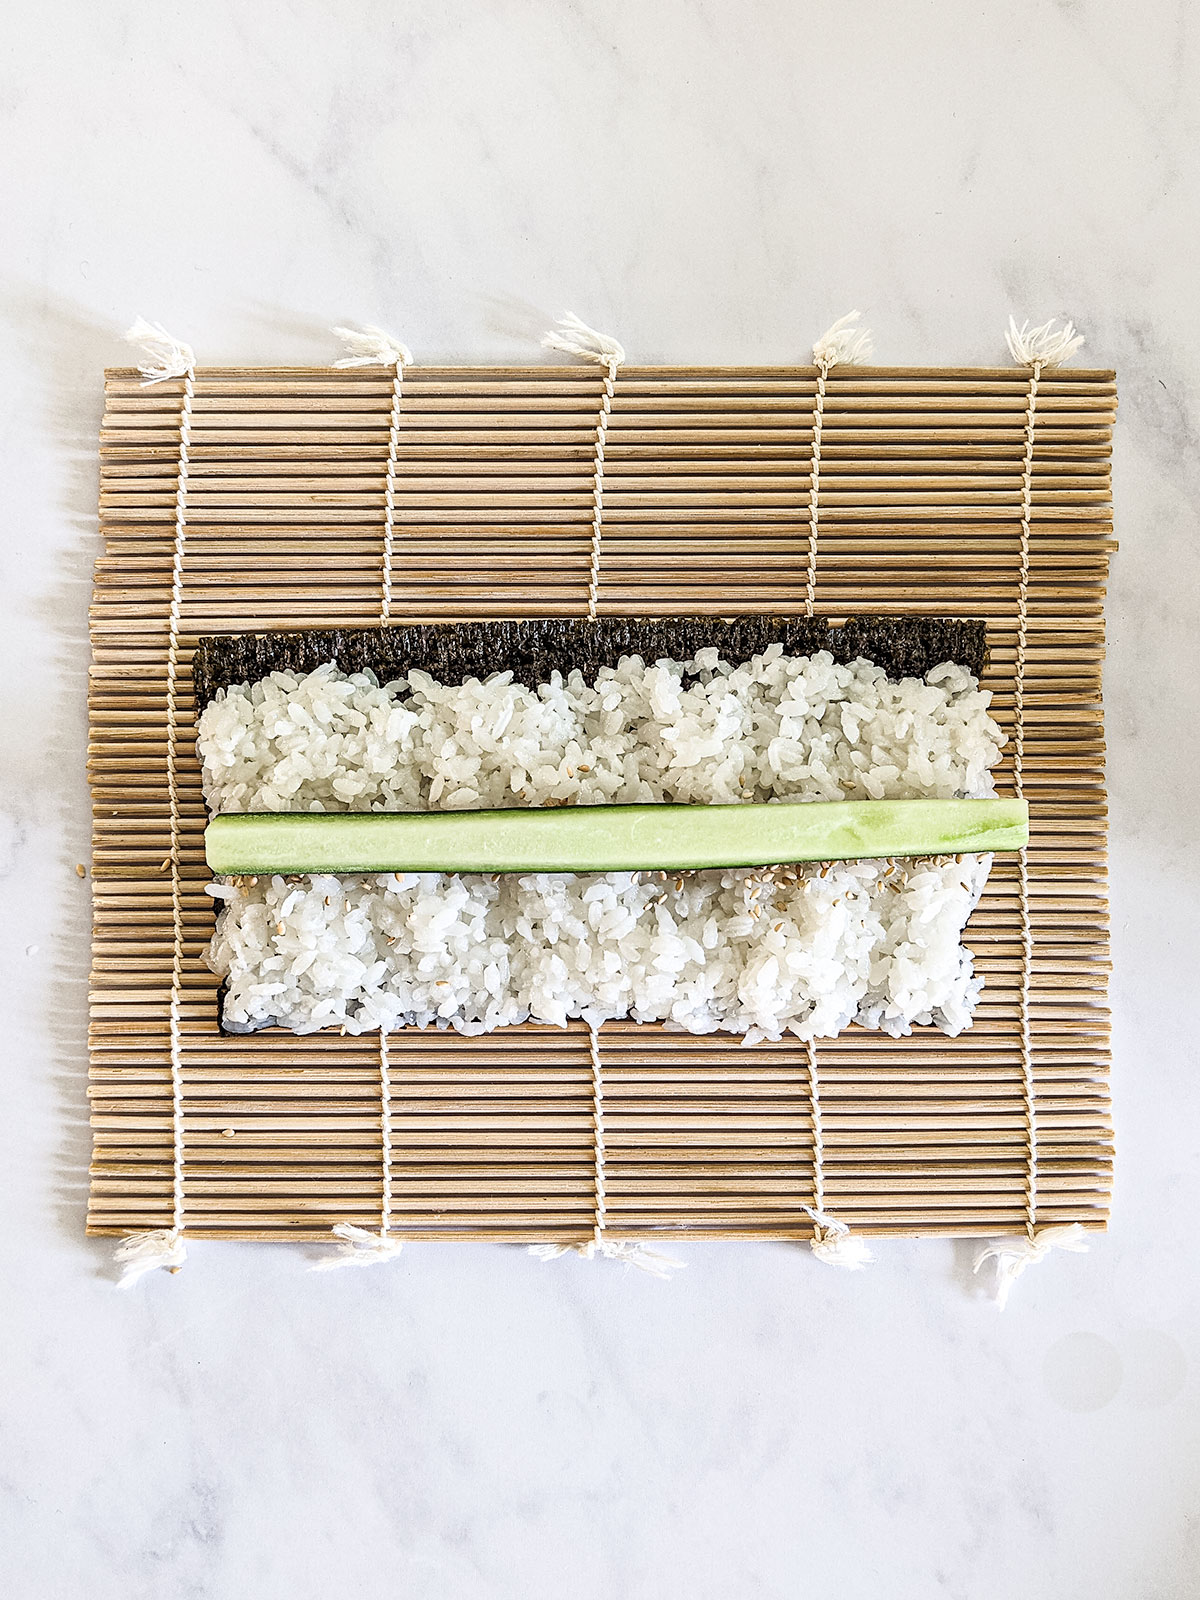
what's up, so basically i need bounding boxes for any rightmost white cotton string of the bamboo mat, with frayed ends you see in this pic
[974,317,1088,1309]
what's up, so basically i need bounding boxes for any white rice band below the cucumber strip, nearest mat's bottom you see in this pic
[213,856,990,1040]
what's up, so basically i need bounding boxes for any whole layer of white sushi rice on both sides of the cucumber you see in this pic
[197,646,1003,1042]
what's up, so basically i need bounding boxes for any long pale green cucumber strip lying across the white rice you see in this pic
[205,800,1029,877]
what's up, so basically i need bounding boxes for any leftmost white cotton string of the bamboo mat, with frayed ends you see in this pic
[115,317,195,1288]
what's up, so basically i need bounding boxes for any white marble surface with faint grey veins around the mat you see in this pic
[0,0,1200,1600]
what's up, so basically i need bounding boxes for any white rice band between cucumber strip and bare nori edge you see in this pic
[197,645,1002,811]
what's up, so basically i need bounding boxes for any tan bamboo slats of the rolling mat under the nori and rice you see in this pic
[88,366,1117,1242]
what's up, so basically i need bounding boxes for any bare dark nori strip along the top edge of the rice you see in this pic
[192,616,987,714]
